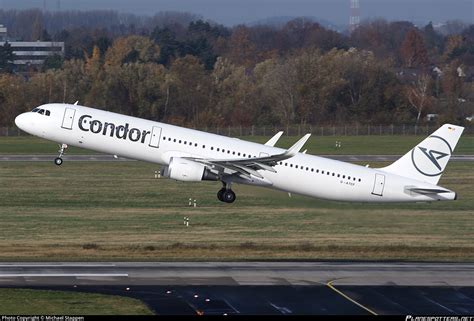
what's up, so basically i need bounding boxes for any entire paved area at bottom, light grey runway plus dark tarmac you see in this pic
[0,262,474,315]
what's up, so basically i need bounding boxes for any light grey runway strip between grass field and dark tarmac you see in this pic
[0,262,474,286]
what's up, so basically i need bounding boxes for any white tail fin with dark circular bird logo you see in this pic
[381,124,464,185]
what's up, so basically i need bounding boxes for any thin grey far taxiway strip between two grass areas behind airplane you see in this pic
[0,154,474,162]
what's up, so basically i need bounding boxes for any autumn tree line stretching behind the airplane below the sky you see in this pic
[0,10,474,127]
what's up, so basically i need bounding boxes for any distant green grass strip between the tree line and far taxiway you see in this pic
[0,136,474,155]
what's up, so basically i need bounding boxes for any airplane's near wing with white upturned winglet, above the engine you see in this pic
[186,134,311,178]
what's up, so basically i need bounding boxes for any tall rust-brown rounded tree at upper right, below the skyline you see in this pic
[400,29,428,68]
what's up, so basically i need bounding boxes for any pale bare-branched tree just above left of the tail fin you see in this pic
[406,74,432,125]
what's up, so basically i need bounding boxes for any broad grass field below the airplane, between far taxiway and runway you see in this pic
[0,162,474,261]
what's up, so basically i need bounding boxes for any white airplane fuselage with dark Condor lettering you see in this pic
[17,104,455,202]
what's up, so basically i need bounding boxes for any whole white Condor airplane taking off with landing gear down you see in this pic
[15,102,464,203]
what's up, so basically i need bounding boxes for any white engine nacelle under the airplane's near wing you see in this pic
[161,157,219,182]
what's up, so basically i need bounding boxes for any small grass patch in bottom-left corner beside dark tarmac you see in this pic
[0,289,152,315]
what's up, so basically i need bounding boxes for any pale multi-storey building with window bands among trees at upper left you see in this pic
[0,25,64,66]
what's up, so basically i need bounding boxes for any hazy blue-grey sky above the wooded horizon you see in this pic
[0,0,474,26]
